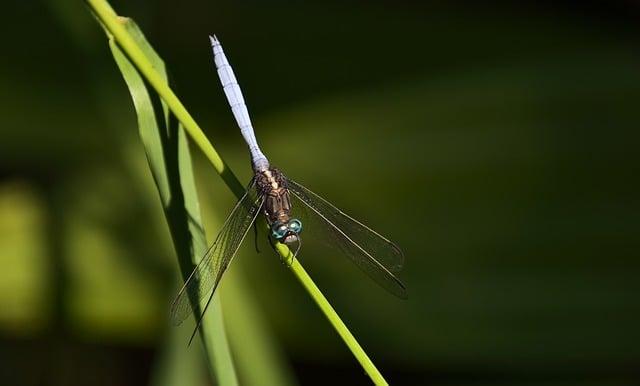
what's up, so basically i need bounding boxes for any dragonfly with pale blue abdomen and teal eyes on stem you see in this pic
[171,35,407,338]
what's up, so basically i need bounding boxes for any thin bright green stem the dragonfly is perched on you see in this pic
[86,0,388,385]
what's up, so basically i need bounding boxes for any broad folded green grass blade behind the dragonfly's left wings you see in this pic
[109,18,238,385]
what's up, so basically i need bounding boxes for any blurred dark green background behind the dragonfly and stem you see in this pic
[0,0,640,385]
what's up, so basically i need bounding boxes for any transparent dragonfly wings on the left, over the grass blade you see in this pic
[171,180,263,325]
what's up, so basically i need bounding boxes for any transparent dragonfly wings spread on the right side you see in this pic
[287,179,407,299]
